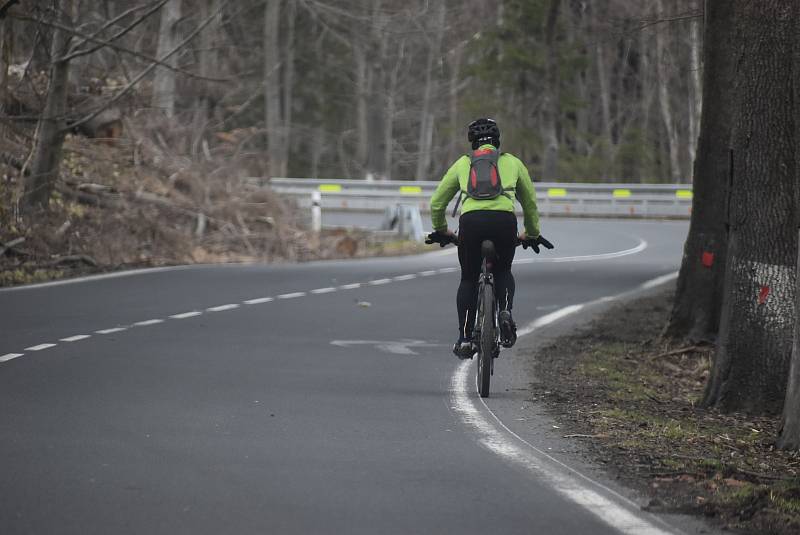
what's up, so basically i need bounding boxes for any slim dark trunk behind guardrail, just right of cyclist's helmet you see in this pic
[542,0,560,181]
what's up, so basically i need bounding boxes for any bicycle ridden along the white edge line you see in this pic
[425,233,553,398]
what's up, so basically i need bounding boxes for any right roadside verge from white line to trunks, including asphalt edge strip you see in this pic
[492,284,800,534]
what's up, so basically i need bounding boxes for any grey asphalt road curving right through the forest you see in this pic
[0,219,687,534]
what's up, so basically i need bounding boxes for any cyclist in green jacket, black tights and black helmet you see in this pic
[429,118,552,359]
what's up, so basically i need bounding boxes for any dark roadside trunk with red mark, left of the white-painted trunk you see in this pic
[665,2,736,340]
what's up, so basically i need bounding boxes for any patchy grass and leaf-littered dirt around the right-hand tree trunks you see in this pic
[532,293,800,535]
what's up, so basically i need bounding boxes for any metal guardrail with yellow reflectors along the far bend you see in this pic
[256,178,692,219]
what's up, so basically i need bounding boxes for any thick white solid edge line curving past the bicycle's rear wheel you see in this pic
[450,273,681,535]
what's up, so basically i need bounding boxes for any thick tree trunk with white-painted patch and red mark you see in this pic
[704,0,797,413]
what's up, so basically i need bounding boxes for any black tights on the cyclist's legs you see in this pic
[456,210,517,337]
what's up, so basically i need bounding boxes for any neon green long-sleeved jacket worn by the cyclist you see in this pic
[431,144,539,238]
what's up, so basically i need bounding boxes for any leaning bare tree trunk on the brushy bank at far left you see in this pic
[20,0,73,214]
